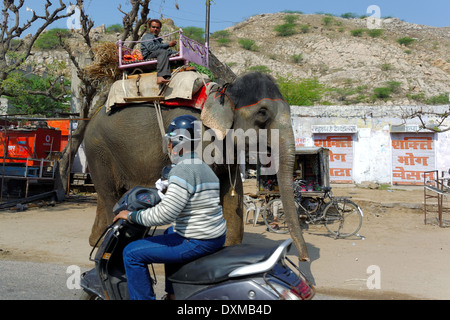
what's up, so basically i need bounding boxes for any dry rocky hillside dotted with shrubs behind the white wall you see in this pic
[210,13,450,105]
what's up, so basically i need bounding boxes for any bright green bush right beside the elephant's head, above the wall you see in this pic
[277,77,326,106]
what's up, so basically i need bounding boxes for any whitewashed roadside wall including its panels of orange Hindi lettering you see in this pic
[291,105,450,185]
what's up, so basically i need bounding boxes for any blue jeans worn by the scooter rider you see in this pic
[123,227,225,300]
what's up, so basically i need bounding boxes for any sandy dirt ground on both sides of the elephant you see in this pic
[0,181,450,299]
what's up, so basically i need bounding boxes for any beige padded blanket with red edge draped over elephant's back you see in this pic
[106,71,210,112]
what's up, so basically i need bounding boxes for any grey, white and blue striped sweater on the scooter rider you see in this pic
[129,153,227,239]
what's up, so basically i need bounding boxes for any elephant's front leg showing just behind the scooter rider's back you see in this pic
[218,165,244,246]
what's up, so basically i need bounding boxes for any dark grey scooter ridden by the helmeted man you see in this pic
[81,187,315,300]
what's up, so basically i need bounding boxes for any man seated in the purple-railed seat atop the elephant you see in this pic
[141,19,177,84]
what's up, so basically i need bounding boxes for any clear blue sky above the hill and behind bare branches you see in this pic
[16,0,450,33]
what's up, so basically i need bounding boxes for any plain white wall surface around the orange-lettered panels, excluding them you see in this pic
[291,106,450,183]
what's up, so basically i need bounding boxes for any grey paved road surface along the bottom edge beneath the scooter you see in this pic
[0,260,337,300]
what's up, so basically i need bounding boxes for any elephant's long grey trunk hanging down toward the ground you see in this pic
[277,117,310,261]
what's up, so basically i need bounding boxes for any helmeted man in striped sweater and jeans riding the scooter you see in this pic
[114,115,227,300]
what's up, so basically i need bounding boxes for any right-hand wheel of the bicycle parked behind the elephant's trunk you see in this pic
[323,199,363,238]
